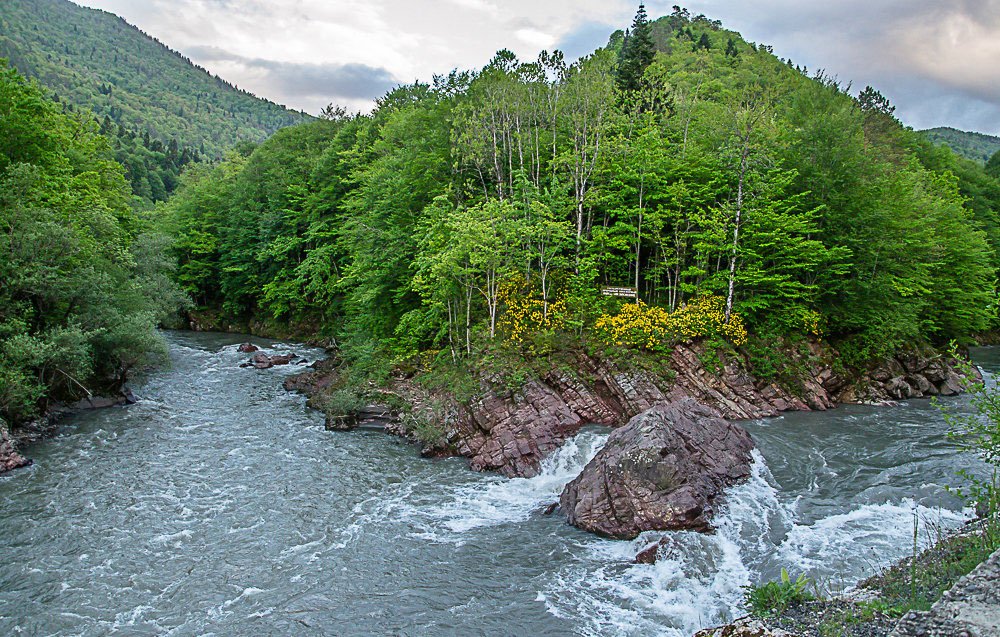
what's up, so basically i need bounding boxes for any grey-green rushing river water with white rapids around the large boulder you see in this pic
[0,333,1000,637]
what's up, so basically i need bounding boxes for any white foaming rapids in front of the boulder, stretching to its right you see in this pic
[538,451,966,637]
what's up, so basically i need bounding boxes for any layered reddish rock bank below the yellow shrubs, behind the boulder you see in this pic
[287,341,962,477]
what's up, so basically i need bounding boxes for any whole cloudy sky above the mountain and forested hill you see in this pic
[76,0,1000,134]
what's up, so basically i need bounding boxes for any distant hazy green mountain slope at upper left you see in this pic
[0,0,309,156]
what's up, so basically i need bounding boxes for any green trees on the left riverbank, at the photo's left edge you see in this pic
[0,64,184,428]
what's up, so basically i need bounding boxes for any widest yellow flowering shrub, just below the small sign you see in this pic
[594,296,747,350]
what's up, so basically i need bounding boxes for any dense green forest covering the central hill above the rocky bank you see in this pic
[157,9,1000,376]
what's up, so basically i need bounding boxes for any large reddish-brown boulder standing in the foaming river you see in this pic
[559,398,754,539]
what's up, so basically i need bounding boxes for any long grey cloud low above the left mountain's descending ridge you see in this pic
[187,46,399,99]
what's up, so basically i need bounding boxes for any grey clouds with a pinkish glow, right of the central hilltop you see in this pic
[688,0,1000,134]
